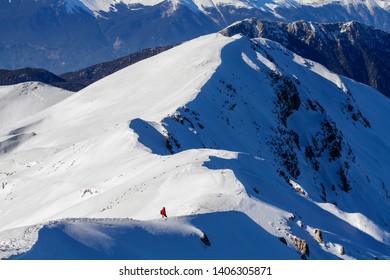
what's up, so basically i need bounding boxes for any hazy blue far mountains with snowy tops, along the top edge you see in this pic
[0,0,390,74]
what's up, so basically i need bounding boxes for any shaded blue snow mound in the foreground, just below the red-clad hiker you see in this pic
[6,212,299,260]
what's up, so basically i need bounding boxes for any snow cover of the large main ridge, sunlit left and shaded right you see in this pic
[0,34,390,259]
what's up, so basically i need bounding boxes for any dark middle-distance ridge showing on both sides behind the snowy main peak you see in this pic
[0,18,390,97]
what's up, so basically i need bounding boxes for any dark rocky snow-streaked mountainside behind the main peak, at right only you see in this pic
[222,18,390,97]
